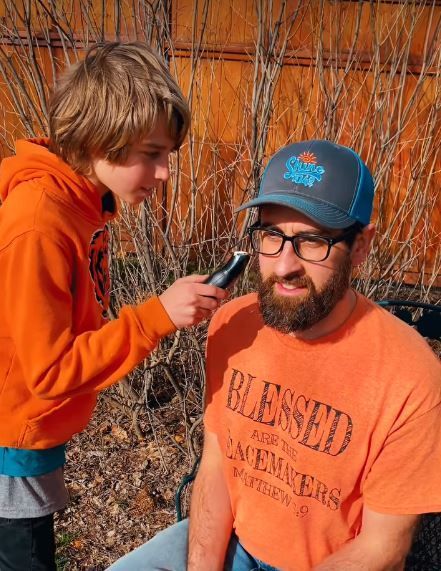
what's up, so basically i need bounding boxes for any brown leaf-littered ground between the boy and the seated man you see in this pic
[55,397,196,571]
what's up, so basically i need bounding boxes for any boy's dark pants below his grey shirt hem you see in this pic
[0,514,57,571]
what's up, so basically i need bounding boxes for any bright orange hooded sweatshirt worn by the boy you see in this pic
[0,139,175,449]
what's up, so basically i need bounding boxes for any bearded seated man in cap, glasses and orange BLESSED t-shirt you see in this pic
[109,141,441,571]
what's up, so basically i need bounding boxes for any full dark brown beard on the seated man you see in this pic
[258,256,352,333]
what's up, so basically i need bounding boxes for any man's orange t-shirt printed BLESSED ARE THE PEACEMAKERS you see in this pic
[205,294,441,571]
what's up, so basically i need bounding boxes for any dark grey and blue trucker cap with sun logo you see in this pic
[236,140,374,229]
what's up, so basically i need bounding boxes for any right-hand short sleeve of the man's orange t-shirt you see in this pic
[363,398,441,515]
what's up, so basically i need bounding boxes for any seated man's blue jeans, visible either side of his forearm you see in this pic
[108,519,277,571]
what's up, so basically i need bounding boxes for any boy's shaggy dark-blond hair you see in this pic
[49,42,190,174]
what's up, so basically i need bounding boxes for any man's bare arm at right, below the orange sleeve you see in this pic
[314,507,419,571]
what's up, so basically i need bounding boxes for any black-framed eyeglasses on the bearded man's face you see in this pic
[247,224,357,262]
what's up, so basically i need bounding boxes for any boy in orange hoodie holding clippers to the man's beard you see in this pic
[0,43,225,571]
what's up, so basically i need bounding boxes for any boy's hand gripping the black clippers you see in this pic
[159,275,228,329]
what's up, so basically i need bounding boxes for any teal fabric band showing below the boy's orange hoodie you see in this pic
[0,444,66,477]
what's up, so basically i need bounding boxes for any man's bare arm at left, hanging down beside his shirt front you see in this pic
[187,430,233,571]
